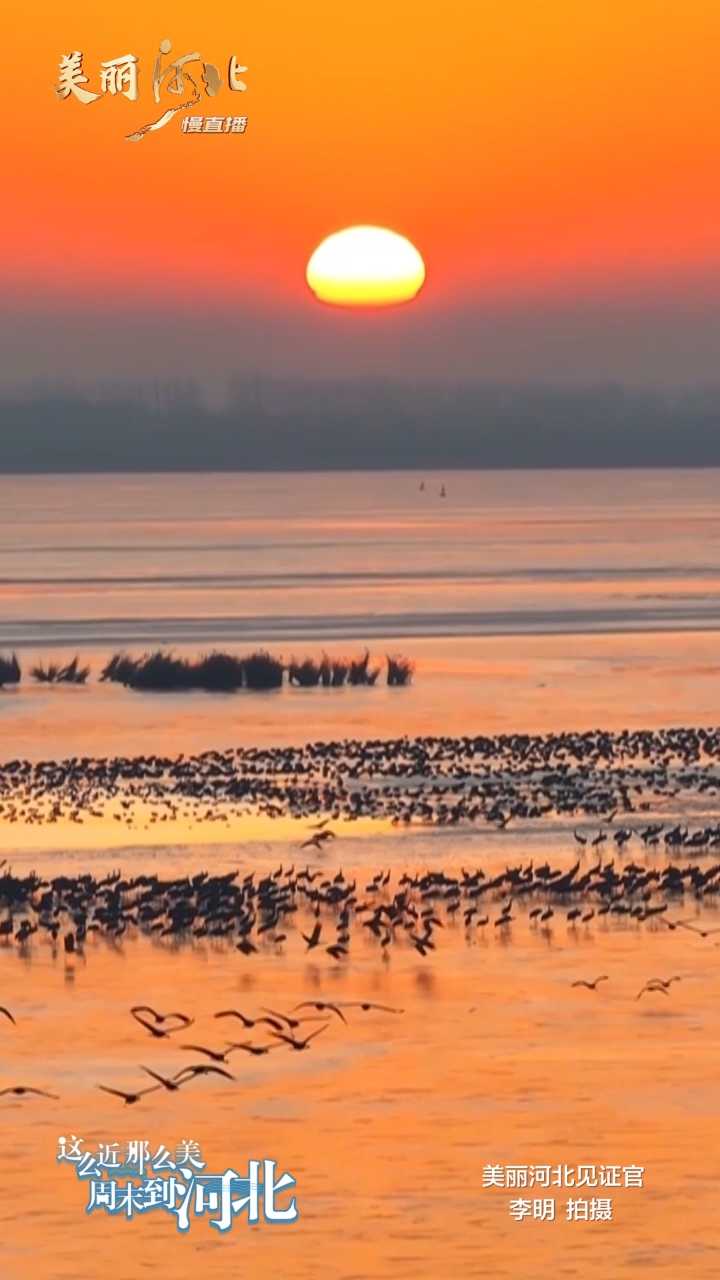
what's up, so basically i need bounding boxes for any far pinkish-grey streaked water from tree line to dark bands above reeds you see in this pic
[0,471,720,648]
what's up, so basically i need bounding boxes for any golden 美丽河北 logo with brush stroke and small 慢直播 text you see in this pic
[55,40,249,142]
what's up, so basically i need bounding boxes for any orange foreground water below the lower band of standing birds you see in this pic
[0,836,720,1280]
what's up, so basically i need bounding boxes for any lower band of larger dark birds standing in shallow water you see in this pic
[0,827,720,964]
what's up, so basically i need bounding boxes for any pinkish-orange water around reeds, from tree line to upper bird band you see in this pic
[0,470,720,756]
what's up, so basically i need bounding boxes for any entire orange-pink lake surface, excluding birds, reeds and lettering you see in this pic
[0,471,720,1280]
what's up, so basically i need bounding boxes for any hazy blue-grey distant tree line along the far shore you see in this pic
[0,383,720,474]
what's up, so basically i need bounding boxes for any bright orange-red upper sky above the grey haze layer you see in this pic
[8,0,720,306]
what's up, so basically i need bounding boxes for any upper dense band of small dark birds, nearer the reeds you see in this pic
[0,728,720,841]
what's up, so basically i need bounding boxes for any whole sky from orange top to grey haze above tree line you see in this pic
[0,0,720,385]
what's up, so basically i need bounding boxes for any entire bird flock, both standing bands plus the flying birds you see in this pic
[0,728,720,1105]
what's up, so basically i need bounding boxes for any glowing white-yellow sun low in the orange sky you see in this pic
[305,227,425,307]
